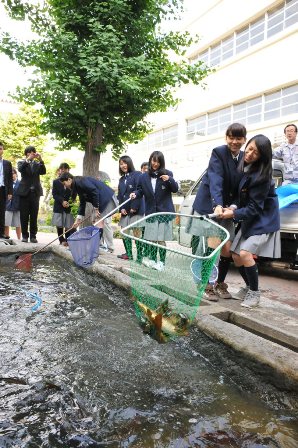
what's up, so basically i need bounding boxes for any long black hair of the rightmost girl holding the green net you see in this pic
[242,134,272,181]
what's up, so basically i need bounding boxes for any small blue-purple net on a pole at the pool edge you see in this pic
[67,226,100,267]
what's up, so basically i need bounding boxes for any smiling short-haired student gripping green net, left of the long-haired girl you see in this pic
[189,123,246,302]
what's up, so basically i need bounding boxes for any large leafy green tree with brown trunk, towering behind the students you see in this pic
[0,0,209,175]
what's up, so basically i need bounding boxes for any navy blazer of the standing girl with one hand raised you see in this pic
[135,170,179,216]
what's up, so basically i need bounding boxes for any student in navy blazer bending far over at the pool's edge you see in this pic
[60,173,117,242]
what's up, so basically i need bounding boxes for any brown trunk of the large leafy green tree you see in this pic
[83,124,103,177]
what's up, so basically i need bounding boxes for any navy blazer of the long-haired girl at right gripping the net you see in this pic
[234,173,280,238]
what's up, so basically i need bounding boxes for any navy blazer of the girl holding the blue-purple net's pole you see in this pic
[118,171,145,215]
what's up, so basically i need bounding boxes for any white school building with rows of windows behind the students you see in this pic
[101,0,298,180]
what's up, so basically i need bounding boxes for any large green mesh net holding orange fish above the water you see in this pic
[122,213,229,341]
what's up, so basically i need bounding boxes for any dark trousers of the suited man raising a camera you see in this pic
[20,191,39,238]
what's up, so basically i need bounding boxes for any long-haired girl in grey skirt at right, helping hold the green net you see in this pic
[221,134,280,308]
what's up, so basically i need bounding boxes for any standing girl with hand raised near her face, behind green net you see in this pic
[131,151,179,271]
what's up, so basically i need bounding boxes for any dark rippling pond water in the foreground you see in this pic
[0,255,298,448]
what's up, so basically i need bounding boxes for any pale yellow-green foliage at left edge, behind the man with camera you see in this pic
[0,105,46,166]
